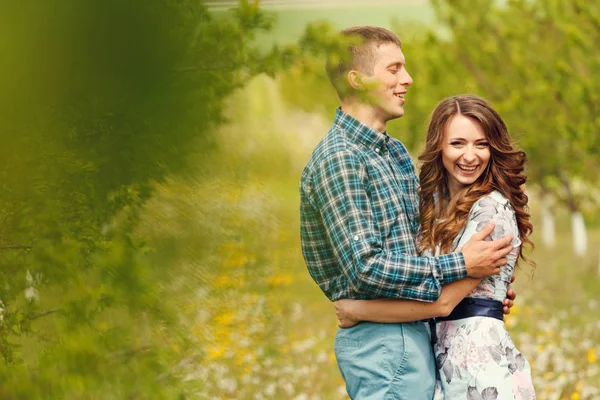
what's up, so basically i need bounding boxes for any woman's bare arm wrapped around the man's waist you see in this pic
[335,278,481,328]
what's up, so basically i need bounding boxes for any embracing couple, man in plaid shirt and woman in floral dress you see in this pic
[300,26,535,400]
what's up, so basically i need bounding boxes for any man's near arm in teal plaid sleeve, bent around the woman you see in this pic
[314,151,467,301]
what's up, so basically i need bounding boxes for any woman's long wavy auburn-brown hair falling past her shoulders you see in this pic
[419,95,535,266]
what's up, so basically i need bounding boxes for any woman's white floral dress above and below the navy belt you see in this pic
[434,191,535,400]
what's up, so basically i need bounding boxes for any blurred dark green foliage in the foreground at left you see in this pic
[0,0,270,399]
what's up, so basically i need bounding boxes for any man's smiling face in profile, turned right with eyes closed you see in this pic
[363,43,412,122]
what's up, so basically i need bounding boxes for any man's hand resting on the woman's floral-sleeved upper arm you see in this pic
[462,222,513,278]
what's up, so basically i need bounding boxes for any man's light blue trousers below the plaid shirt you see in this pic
[334,322,435,400]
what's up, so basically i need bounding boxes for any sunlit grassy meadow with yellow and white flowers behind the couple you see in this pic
[145,77,600,400]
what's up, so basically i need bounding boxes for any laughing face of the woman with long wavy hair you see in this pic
[442,114,490,196]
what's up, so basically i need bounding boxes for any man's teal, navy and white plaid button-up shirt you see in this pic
[300,108,467,302]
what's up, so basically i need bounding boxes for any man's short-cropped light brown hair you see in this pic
[326,26,402,99]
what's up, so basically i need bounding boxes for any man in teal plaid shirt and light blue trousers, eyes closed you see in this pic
[300,27,512,400]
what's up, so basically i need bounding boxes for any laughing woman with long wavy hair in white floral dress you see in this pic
[336,95,535,400]
